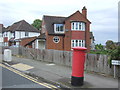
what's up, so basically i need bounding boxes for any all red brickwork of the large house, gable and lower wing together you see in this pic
[42,11,91,52]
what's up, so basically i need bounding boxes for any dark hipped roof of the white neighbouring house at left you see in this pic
[8,20,40,33]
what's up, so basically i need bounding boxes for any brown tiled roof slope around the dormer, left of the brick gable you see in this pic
[43,15,66,34]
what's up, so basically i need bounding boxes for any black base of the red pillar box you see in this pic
[71,76,84,86]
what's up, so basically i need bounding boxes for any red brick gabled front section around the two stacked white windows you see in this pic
[65,11,91,52]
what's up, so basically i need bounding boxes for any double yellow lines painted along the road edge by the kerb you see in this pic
[0,64,57,90]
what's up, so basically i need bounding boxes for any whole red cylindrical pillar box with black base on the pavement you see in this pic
[71,47,87,86]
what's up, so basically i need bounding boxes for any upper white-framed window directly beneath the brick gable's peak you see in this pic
[71,22,85,31]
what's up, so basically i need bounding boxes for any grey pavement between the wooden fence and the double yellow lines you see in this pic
[0,55,120,88]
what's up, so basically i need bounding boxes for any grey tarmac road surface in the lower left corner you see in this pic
[0,63,56,90]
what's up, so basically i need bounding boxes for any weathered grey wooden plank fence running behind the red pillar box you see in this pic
[1,47,119,76]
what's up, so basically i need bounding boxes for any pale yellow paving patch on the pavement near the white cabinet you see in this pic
[11,63,34,71]
